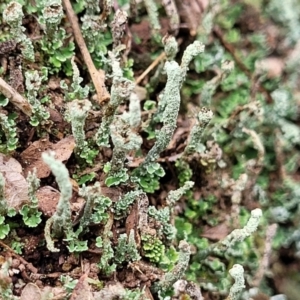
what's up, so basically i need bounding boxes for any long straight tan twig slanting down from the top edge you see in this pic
[62,0,110,104]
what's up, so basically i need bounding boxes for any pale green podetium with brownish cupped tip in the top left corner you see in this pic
[3,1,34,61]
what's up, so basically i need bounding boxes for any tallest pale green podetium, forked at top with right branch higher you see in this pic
[140,39,204,173]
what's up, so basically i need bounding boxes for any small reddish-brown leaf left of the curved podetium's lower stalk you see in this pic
[36,186,60,217]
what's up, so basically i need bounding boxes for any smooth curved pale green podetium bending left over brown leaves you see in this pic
[42,153,73,251]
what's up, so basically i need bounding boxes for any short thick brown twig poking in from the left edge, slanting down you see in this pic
[0,77,32,116]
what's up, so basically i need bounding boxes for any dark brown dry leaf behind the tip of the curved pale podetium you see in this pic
[21,136,75,178]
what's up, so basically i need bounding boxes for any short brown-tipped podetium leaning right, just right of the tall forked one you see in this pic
[183,107,213,156]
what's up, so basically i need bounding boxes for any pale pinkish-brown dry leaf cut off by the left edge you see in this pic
[0,153,29,209]
